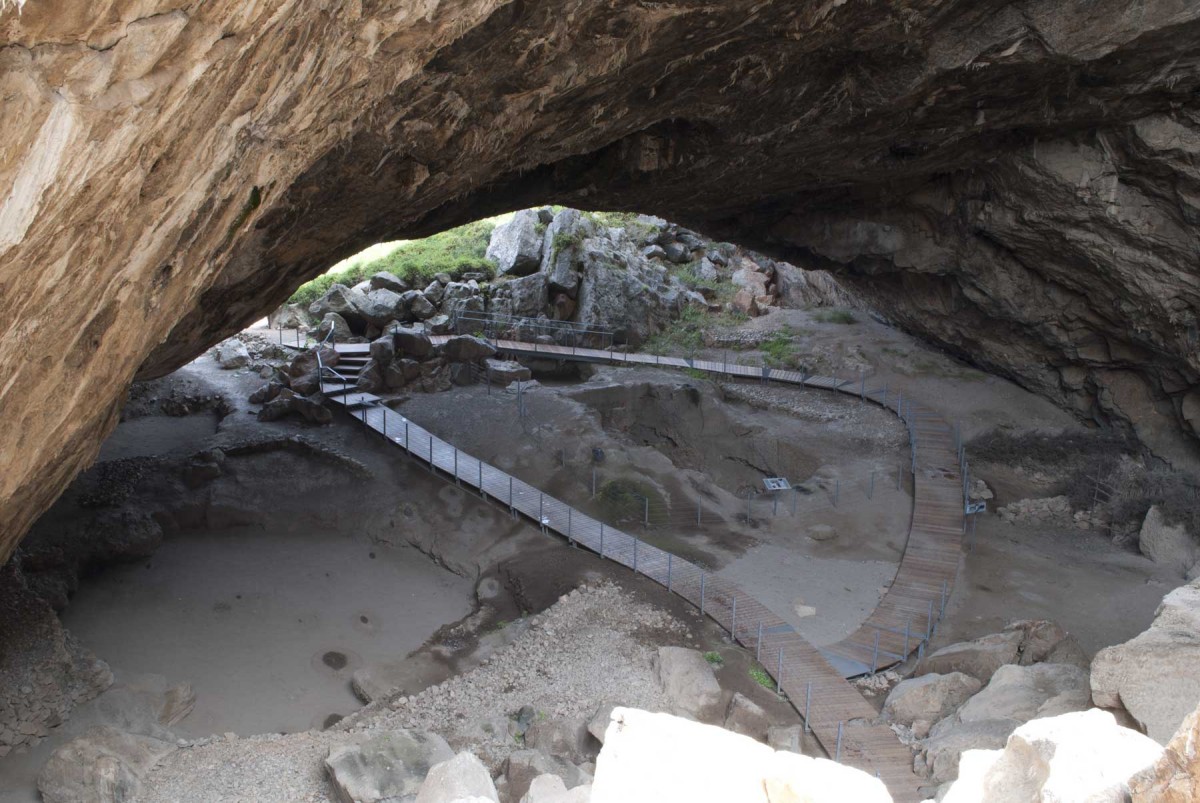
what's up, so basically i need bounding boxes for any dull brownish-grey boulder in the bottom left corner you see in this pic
[37,725,178,803]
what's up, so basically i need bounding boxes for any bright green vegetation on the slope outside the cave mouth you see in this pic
[289,218,496,304]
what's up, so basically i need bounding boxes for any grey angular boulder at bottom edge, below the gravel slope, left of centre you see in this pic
[325,730,453,803]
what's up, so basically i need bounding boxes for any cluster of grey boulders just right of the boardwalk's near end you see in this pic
[883,621,1091,784]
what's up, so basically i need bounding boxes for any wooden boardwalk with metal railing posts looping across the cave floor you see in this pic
[326,337,962,802]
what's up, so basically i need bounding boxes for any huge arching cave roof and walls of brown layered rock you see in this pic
[0,0,1200,557]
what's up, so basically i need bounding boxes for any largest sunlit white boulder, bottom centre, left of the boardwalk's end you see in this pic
[592,708,892,803]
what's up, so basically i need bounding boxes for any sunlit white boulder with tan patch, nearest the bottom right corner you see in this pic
[946,708,1163,803]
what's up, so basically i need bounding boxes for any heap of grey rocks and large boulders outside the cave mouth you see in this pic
[274,208,851,348]
